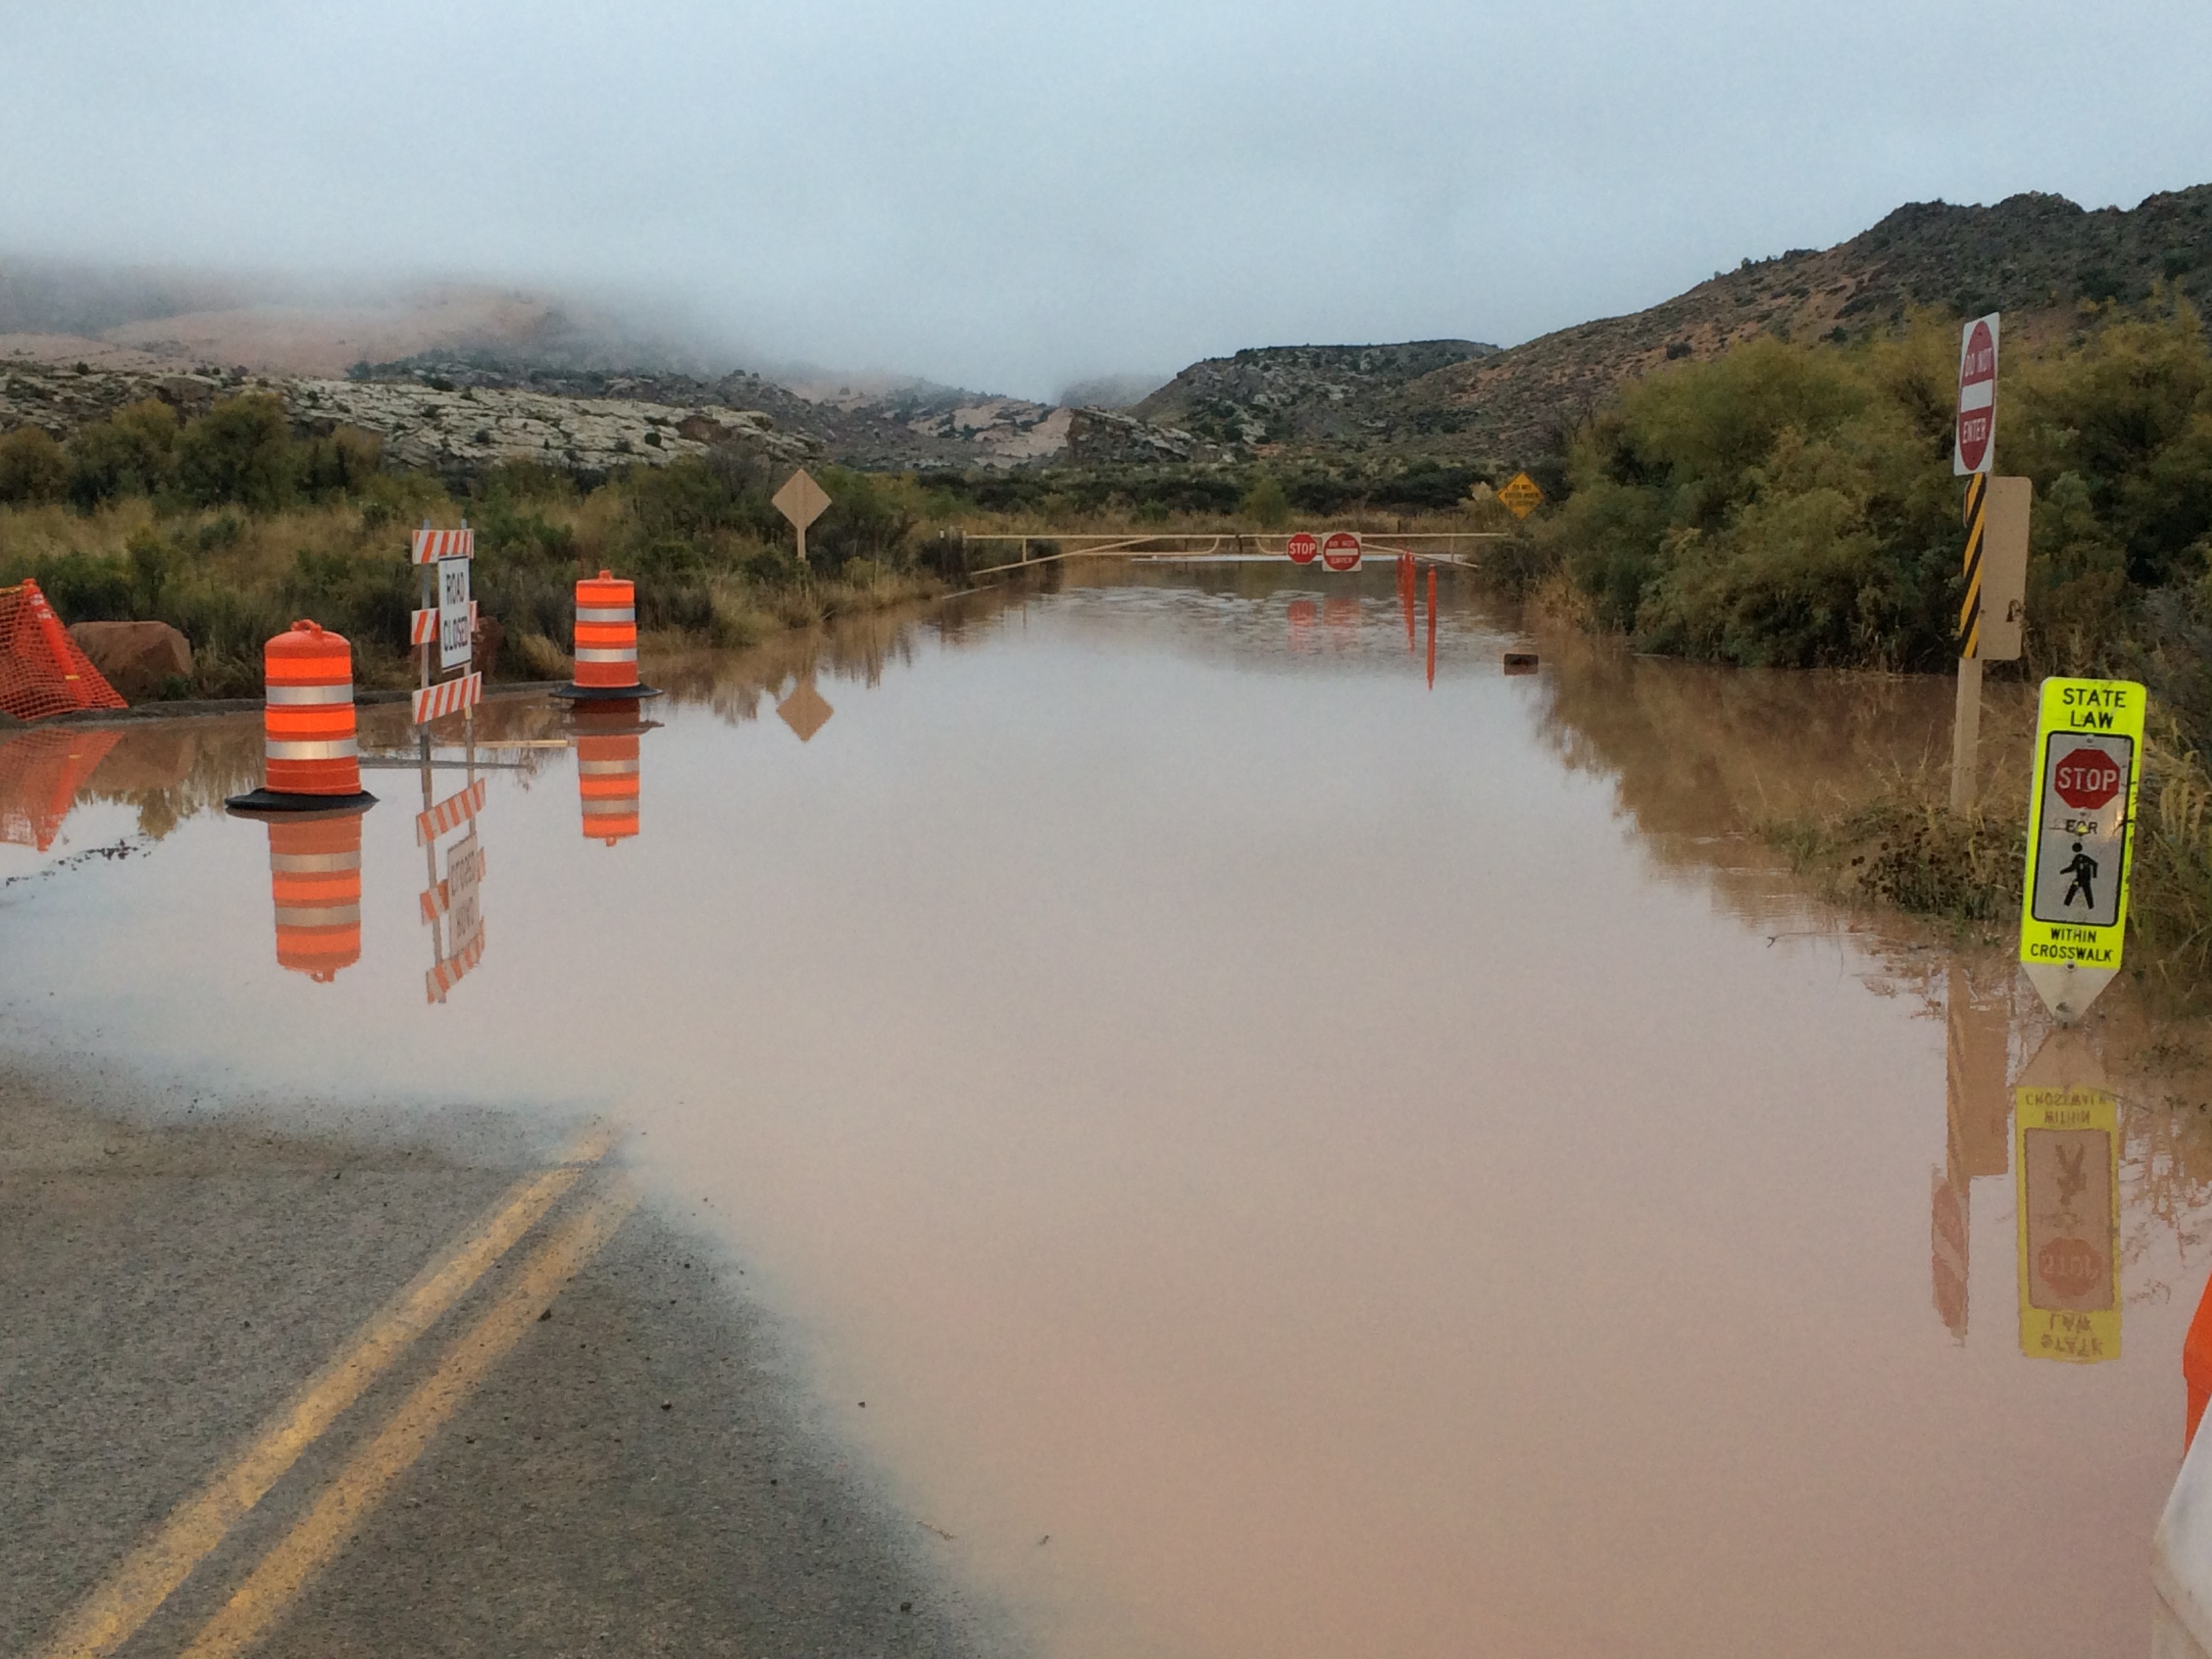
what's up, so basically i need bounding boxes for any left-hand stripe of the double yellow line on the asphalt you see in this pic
[35,1124,621,1659]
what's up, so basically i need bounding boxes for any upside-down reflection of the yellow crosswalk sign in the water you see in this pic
[2013,1088,2119,1365]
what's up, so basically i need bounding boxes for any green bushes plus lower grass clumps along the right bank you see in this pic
[1511,294,2212,996]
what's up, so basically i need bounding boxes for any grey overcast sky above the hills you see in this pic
[0,0,2212,396]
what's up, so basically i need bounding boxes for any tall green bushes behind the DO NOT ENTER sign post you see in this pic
[1531,301,2212,672]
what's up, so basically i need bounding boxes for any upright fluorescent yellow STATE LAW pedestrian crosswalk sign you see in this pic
[2020,679,2148,969]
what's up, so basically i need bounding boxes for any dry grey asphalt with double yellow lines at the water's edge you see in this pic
[0,1071,1008,1659]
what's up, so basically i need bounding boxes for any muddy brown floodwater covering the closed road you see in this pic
[0,567,2212,1659]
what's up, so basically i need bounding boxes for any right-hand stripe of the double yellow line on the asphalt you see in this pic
[184,1181,637,1659]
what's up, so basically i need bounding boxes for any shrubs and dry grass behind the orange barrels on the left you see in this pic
[0,394,940,697]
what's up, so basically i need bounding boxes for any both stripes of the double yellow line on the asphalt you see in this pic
[35,1126,637,1659]
